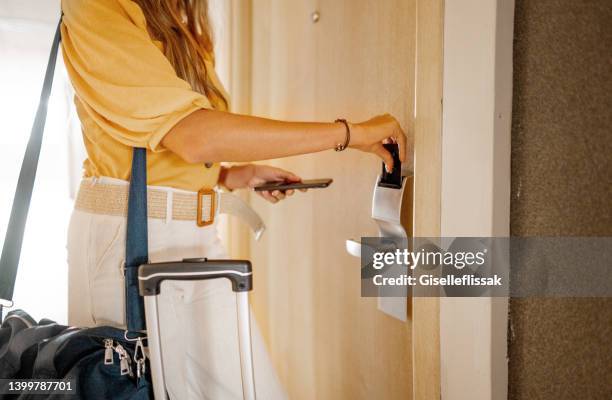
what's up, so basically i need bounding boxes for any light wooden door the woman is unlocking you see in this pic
[250,0,416,400]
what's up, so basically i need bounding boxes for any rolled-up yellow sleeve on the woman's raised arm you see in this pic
[62,0,212,151]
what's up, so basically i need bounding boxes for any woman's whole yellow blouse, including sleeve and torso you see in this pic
[62,0,227,191]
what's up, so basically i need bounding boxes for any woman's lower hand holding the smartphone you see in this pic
[219,164,302,203]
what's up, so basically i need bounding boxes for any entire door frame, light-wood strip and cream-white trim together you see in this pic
[412,0,514,400]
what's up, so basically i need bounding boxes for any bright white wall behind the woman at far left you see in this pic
[0,0,82,323]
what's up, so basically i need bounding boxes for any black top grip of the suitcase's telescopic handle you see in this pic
[138,258,253,296]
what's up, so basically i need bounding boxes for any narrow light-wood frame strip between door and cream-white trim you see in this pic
[412,0,445,400]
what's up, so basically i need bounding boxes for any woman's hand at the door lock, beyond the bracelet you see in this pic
[349,114,407,172]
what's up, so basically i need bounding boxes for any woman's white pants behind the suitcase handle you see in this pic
[68,178,287,400]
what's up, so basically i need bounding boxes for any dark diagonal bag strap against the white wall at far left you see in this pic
[0,18,61,318]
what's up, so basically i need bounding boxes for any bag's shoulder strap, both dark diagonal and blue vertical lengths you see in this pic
[0,18,149,331]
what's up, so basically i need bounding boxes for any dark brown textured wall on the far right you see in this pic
[508,0,612,400]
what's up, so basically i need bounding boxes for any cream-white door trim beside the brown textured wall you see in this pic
[440,0,514,400]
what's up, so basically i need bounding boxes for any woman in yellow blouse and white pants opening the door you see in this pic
[62,0,406,400]
